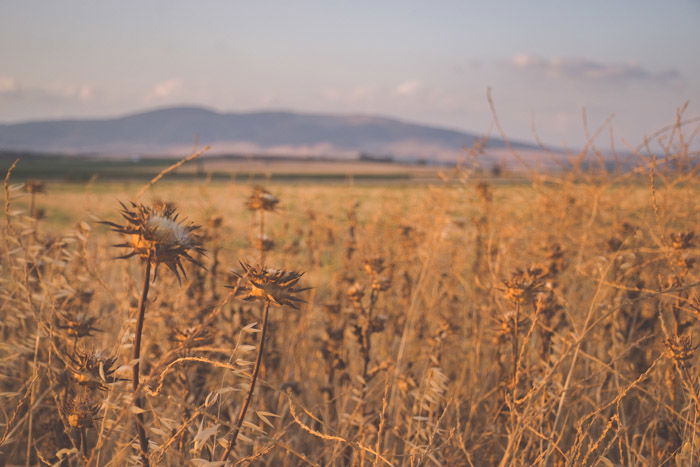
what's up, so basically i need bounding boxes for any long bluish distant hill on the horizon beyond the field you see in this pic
[0,107,536,162]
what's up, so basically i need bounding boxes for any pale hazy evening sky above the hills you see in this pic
[0,0,700,147]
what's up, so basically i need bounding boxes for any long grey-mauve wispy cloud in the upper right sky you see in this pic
[511,54,680,83]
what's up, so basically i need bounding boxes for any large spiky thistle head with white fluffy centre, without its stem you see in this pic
[101,202,205,281]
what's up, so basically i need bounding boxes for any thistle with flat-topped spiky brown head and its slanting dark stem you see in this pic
[221,262,309,462]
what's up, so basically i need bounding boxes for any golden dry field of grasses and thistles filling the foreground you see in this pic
[0,114,700,466]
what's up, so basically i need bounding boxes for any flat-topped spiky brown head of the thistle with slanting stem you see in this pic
[230,262,309,309]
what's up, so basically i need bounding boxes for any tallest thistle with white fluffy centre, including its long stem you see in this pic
[102,202,205,466]
